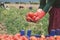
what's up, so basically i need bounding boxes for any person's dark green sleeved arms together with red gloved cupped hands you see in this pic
[27,0,55,22]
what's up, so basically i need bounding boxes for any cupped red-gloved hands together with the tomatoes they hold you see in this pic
[26,9,45,22]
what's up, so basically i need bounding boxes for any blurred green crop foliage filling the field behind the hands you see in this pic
[0,8,48,35]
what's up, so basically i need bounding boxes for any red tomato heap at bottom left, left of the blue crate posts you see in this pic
[0,33,28,40]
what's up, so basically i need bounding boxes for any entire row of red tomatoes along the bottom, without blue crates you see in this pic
[0,33,60,40]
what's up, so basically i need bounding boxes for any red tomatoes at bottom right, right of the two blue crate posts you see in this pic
[30,36,60,40]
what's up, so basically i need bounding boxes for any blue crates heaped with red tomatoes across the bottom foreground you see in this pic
[0,30,60,40]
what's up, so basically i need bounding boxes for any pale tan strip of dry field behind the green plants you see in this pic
[5,4,39,8]
